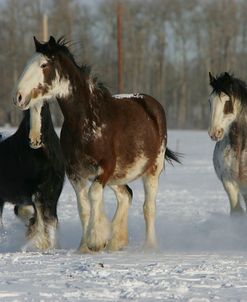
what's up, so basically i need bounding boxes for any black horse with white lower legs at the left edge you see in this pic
[0,104,65,250]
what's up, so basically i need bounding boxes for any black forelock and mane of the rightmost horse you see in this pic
[210,72,247,105]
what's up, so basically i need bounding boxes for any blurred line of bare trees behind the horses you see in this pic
[0,0,247,129]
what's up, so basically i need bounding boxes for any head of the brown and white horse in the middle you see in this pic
[13,36,69,110]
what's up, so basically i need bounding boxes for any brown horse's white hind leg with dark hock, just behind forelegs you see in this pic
[108,185,132,251]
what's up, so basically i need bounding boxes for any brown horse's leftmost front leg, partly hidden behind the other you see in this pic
[71,179,90,253]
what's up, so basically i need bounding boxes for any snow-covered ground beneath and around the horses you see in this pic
[0,131,247,302]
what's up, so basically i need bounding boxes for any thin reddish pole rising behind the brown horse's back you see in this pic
[117,0,124,93]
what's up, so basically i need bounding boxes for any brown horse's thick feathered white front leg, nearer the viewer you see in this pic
[86,180,111,251]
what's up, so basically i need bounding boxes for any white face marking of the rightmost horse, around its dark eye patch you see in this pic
[208,92,239,141]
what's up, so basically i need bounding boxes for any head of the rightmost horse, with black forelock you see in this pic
[208,72,240,141]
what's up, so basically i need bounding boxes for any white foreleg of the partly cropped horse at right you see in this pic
[222,179,243,214]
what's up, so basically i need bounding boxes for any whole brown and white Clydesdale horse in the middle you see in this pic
[14,37,179,251]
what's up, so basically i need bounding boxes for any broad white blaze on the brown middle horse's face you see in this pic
[14,54,48,109]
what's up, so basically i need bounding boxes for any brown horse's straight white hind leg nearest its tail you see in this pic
[143,148,165,248]
